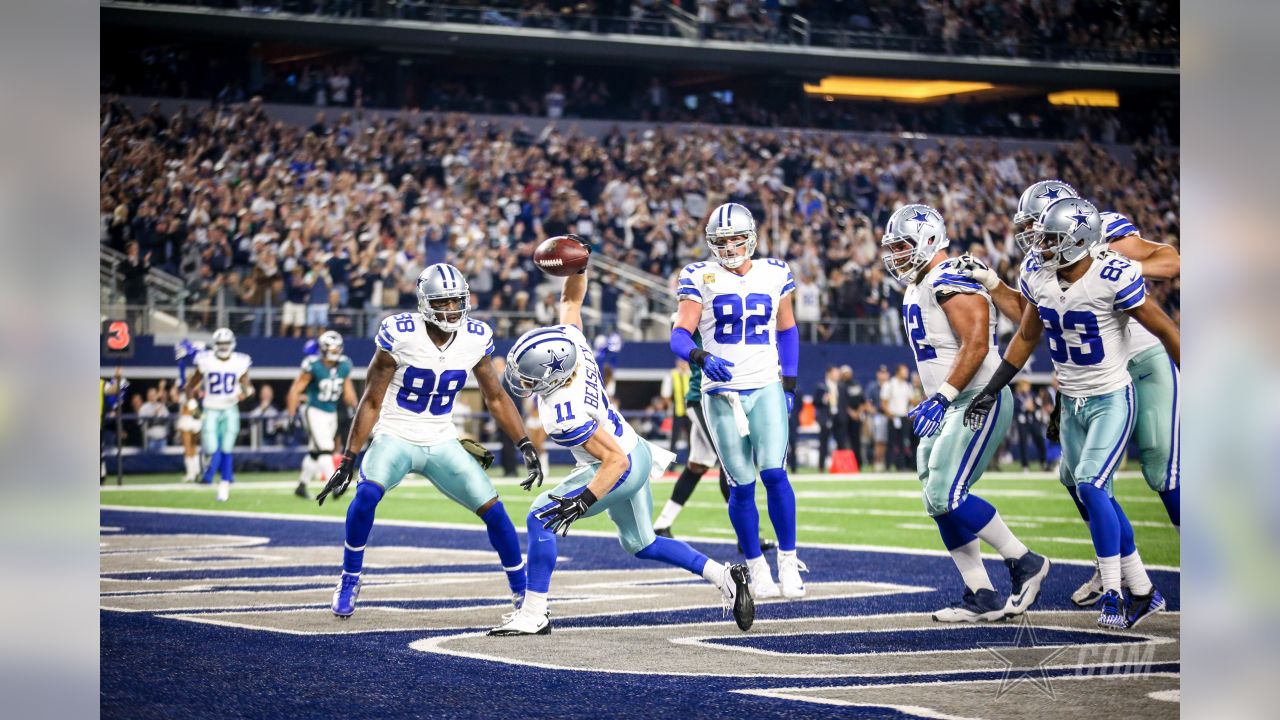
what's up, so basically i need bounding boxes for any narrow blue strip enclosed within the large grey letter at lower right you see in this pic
[703,625,1146,655]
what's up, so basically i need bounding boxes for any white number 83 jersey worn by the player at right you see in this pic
[1018,252,1147,397]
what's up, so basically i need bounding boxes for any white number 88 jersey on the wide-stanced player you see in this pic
[374,313,493,446]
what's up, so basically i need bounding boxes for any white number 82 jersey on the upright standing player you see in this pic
[676,258,796,392]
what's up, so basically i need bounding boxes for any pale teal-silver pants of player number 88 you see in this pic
[360,434,498,512]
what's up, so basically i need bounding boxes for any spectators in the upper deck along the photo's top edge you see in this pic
[142,0,1179,64]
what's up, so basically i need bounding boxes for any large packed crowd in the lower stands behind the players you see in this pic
[100,99,1179,342]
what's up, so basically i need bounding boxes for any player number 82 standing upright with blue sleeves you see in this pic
[671,202,806,600]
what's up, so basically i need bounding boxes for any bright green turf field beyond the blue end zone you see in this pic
[101,468,1179,566]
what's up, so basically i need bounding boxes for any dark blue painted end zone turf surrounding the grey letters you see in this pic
[100,510,1180,720]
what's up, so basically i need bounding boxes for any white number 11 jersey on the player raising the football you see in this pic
[538,325,639,465]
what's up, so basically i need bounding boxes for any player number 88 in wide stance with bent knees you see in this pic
[316,263,543,618]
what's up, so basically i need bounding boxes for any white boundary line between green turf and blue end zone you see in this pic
[99,505,1181,574]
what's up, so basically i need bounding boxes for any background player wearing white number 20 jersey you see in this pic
[186,328,253,502]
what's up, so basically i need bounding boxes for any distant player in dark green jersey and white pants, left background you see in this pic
[285,331,357,498]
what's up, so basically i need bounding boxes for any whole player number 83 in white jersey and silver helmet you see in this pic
[965,197,1180,628]
